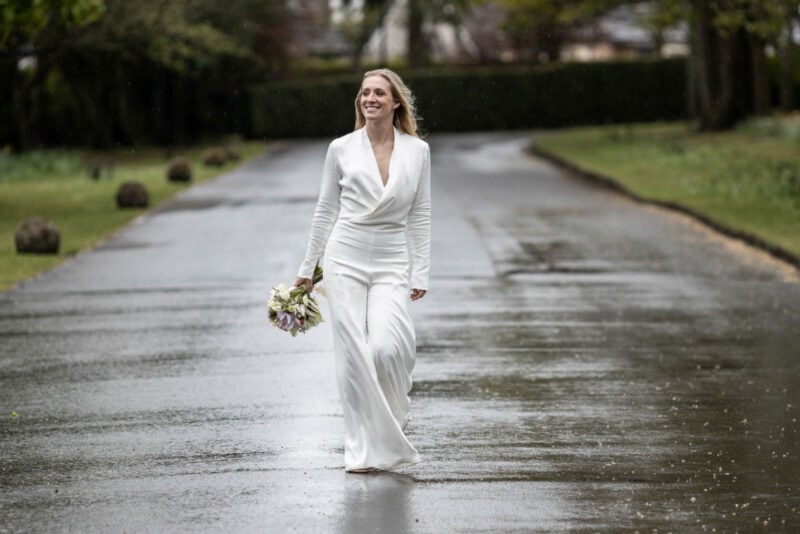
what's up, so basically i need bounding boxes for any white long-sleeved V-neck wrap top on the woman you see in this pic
[298,128,431,290]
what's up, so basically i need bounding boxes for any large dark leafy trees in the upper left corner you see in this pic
[0,0,284,147]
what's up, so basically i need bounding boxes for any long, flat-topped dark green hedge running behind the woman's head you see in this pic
[250,59,686,138]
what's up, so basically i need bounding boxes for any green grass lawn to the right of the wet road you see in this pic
[535,119,800,264]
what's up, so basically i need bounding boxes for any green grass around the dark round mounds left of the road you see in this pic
[0,142,266,290]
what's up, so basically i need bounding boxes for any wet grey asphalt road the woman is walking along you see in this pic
[0,134,800,533]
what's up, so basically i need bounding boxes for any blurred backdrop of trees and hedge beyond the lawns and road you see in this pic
[0,0,800,151]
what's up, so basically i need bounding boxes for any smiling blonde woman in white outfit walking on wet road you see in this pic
[295,69,431,472]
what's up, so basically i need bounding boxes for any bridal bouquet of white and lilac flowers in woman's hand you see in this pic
[267,265,324,337]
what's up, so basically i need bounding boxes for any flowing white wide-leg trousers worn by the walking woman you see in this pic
[323,223,419,471]
